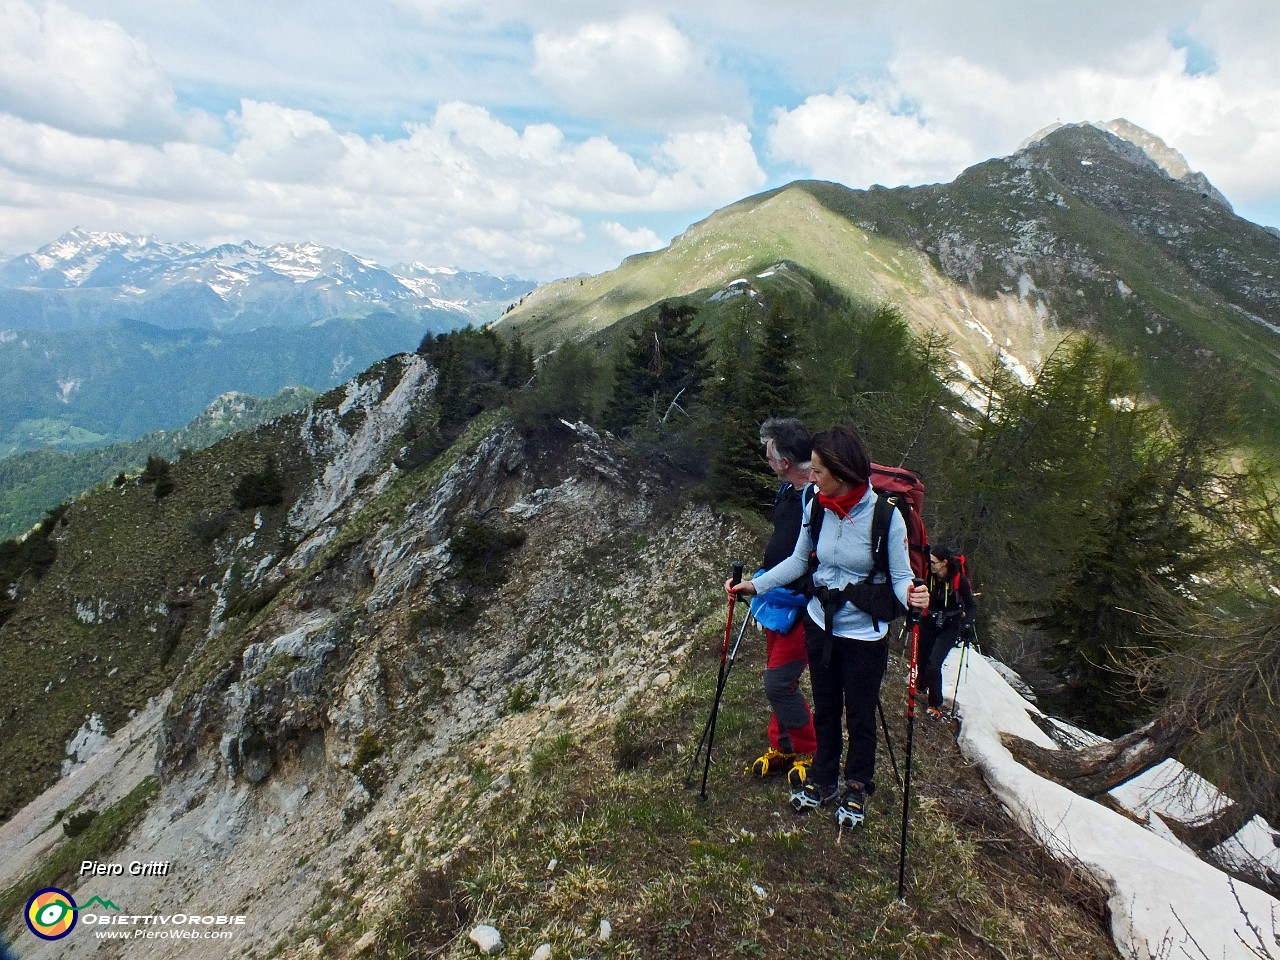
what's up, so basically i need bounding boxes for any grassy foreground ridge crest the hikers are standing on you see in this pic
[363,632,1115,960]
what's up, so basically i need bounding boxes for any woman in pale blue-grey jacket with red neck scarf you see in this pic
[724,426,929,826]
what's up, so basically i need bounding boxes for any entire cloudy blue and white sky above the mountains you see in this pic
[0,0,1280,280]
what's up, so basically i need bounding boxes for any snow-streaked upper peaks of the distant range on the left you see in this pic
[0,228,535,329]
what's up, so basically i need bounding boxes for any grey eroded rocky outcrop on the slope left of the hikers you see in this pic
[160,394,686,814]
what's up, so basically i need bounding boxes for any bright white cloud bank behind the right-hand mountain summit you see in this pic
[767,19,1280,229]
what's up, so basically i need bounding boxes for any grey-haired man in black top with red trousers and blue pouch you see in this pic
[751,417,818,787]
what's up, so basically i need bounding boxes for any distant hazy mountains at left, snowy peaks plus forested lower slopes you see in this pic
[0,229,535,457]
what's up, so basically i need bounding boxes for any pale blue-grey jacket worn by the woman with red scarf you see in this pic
[751,486,914,640]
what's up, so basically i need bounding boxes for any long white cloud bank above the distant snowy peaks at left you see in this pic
[0,100,764,276]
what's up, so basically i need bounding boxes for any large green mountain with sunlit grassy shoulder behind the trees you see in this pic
[502,134,1280,457]
